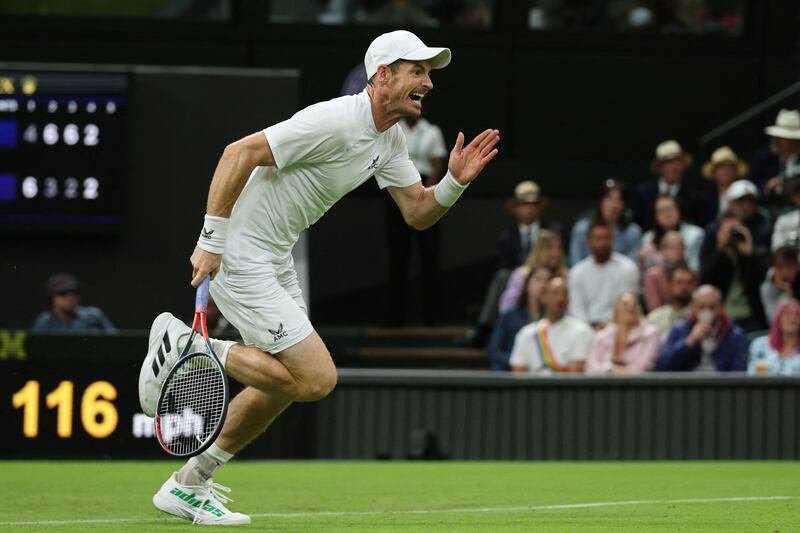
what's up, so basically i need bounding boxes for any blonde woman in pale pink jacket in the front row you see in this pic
[585,292,660,374]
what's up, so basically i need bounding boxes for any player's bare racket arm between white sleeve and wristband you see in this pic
[206,131,275,218]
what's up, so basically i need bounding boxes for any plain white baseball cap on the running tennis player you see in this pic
[364,30,452,79]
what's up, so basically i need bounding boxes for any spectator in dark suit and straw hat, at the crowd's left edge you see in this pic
[467,181,561,346]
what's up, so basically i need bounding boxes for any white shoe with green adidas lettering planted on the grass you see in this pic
[153,472,250,526]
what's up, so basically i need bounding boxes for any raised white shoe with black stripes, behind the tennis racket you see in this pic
[139,313,197,416]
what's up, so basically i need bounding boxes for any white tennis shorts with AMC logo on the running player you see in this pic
[210,257,314,354]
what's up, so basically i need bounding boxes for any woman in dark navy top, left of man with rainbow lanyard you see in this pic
[489,264,553,370]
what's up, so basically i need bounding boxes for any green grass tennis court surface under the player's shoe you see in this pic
[0,461,800,533]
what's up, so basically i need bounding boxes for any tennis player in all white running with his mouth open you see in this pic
[139,30,500,524]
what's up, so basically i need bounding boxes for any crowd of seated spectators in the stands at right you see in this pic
[484,110,800,374]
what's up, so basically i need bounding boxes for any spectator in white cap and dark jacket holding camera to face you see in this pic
[701,180,769,331]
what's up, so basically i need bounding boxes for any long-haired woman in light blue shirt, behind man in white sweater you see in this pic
[569,180,642,265]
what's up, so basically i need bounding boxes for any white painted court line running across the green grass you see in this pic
[0,496,800,526]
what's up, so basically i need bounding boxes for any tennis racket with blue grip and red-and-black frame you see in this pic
[155,277,228,457]
